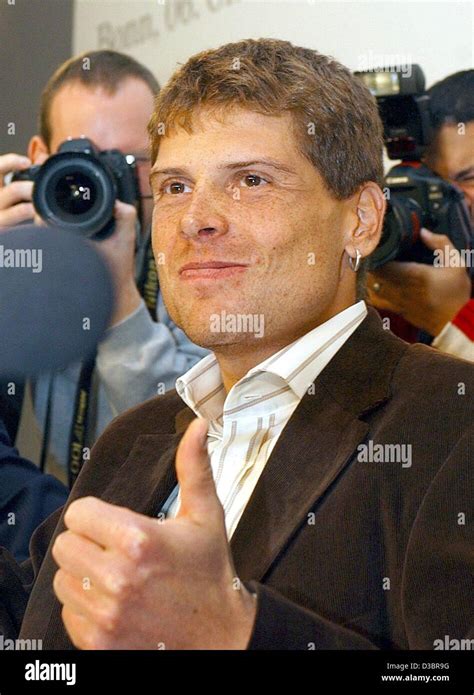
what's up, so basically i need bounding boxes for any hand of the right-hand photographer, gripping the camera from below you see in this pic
[367,229,471,337]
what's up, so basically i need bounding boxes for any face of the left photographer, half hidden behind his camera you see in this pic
[33,78,153,224]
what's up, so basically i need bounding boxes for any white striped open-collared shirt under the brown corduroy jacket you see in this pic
[162,301,367,539]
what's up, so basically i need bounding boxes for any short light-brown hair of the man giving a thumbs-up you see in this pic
[149,39,383,199]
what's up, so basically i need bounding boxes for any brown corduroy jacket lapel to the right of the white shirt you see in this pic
[230,310,408,581]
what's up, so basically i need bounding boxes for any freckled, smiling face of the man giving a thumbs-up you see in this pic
[152,108,355,349]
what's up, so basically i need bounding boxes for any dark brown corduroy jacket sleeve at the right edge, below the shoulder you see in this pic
[402,422,474,649]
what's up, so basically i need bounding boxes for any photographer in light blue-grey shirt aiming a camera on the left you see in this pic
[0,51,206,473]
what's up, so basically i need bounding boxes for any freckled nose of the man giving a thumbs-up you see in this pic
[181,188,228,240]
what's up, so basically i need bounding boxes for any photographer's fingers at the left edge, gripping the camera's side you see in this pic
[0,153,35,227]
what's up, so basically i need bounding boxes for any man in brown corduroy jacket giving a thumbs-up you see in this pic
[0,39,474,649]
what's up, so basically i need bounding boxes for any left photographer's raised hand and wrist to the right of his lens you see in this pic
[94,200,141,326]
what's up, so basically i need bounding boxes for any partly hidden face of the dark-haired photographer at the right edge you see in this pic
[427,122,474,222]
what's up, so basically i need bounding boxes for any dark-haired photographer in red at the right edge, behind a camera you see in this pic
[367,70,474,361]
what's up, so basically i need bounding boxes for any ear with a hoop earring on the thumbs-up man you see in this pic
[345,181,387,258]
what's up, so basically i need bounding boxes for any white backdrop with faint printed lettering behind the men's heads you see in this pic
[73,0,474,86]
